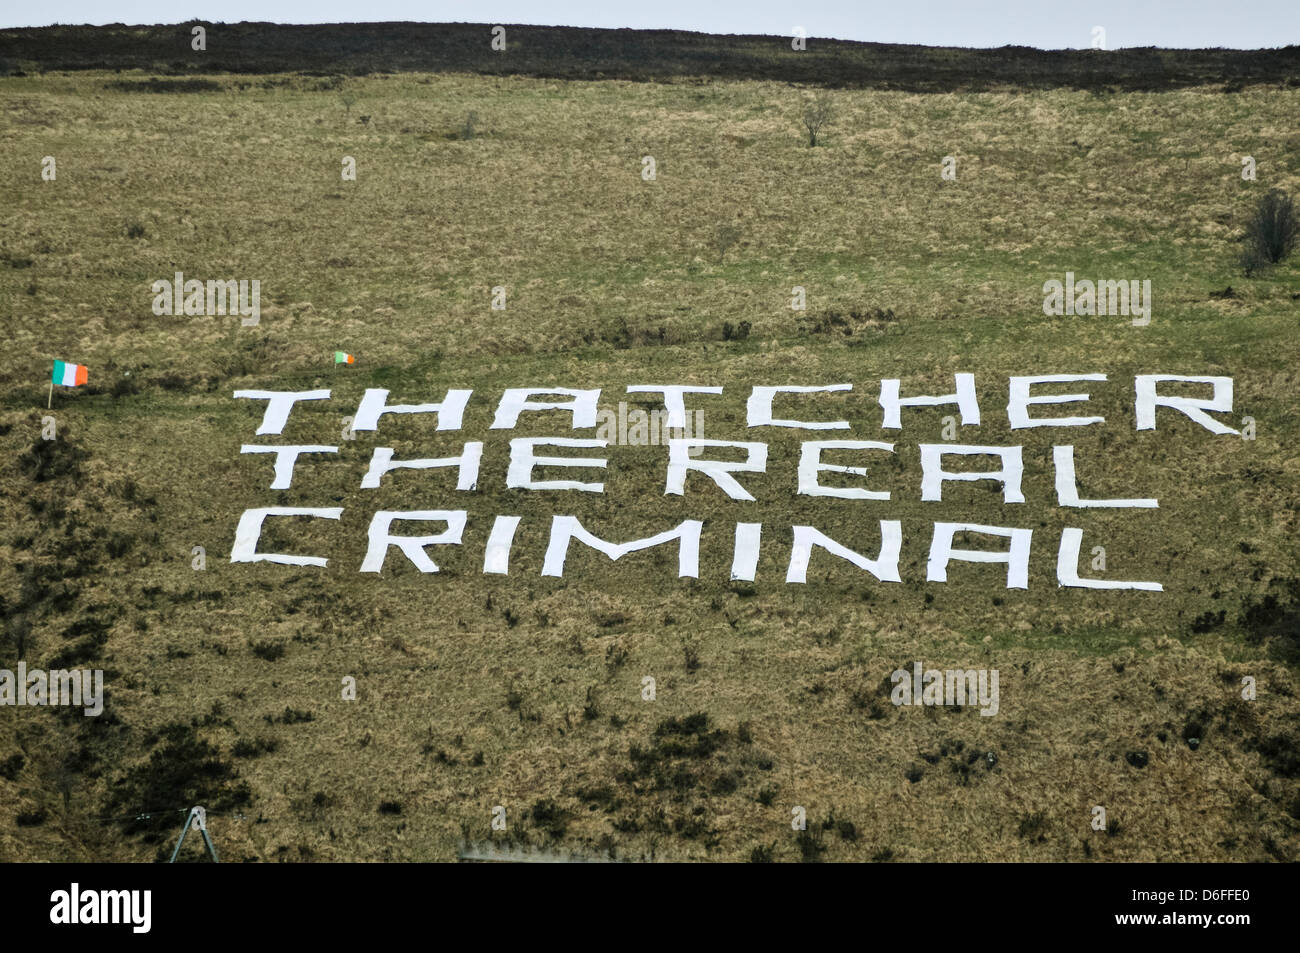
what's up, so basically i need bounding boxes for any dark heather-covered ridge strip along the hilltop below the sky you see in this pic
[0,21,1300,92]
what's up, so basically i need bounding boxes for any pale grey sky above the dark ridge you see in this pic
[0,0,1300,49]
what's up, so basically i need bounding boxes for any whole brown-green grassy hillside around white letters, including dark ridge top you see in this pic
[0,25,1300,861]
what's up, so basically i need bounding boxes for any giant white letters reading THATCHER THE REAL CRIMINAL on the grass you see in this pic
[230,373,1239,592]
